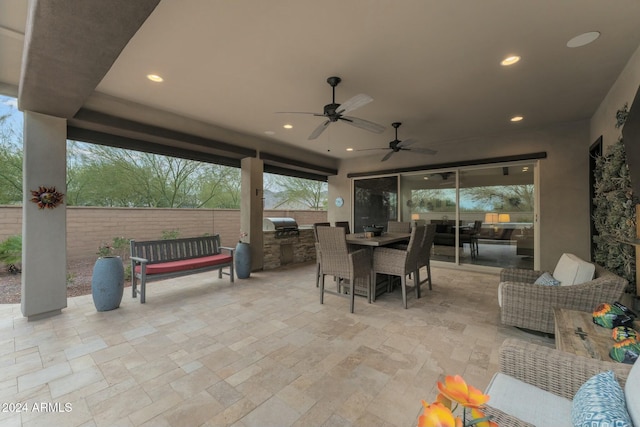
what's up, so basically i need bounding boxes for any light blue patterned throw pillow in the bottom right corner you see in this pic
[571,371,633,427]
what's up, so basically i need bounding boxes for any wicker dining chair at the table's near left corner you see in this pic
[316,227,371,313]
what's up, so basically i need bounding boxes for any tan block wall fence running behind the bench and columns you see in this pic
[0,206,327,261]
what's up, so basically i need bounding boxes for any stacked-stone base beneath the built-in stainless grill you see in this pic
[263,229,323,270]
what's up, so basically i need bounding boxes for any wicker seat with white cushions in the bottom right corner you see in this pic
[485,338,640,427]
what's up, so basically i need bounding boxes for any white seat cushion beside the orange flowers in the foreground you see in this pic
[485,373,573,427]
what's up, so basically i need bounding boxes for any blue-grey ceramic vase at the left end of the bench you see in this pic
[91,256,124,311]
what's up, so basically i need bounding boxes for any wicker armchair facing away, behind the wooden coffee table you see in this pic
[498,254,628,334]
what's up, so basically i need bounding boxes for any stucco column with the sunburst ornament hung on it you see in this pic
[21,111,67,320]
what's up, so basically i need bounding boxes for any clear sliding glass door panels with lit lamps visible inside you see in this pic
[400,163,535,268]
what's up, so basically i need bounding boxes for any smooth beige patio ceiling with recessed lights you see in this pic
[0,0,640,163]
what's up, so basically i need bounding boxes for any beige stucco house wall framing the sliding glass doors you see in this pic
[336,120,590,270]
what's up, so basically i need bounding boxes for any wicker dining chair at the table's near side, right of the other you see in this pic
[373,225,426,308]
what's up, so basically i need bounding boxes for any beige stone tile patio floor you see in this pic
[0,263,553,427]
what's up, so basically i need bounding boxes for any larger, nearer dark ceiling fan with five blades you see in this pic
[276,77,385,139]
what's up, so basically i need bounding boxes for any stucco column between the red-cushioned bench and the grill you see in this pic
[240,157,264,271]
